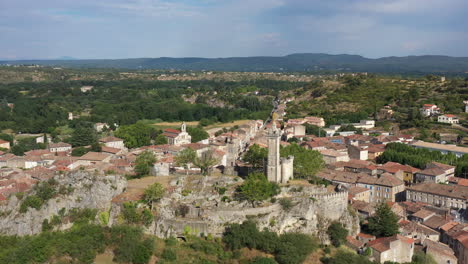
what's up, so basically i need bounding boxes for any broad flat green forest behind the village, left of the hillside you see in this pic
[0,77,302,133]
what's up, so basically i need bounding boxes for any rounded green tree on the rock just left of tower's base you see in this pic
[238,173,279,206]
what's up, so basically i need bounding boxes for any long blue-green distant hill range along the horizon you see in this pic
[0,53,468,73]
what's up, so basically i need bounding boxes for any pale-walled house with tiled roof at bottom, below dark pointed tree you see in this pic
[367,235,414,263]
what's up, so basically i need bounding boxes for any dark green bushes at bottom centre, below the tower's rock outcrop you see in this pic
[223,221,318,264]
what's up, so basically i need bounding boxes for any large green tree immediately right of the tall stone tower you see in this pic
[280,143,325,179]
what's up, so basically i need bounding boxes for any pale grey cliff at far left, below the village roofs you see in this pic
[0,171,127,236]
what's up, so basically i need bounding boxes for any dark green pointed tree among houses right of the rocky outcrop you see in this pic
[369,202,399,237]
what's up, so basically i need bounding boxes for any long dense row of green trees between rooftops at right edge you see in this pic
[377,143,468,177]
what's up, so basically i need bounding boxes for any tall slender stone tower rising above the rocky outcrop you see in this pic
[266,119,281,182]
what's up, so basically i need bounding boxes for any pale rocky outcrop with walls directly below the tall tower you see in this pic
[139,176,359,243]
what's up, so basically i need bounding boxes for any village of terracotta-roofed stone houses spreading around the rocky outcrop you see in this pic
[0,94,468,263]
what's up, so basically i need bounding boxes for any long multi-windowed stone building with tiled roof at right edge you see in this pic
[406,182,468,210]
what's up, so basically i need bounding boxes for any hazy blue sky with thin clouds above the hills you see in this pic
[0,0,468,60]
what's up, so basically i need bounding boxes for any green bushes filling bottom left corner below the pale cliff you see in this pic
[0,224,154,264]
